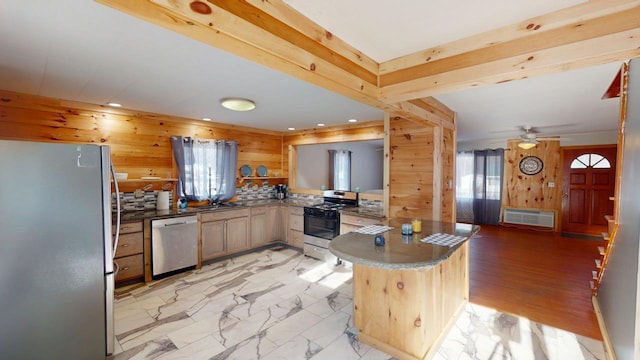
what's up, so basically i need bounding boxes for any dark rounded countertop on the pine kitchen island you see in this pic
[329,219,480,270]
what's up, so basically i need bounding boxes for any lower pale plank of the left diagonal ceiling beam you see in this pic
[96,0,387,108]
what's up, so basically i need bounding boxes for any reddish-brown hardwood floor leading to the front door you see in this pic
[469,225,603,340]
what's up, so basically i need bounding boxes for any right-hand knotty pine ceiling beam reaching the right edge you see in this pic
[380,0,640,103]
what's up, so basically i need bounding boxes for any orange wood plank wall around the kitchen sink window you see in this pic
[0,90,283,186]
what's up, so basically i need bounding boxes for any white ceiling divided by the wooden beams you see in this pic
[0,0,620,141]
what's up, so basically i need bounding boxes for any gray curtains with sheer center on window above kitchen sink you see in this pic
[171,136,238,202]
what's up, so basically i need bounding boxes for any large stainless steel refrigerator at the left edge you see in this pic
[0,140,114,359]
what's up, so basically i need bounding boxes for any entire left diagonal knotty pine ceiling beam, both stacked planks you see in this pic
[96,0,453,127]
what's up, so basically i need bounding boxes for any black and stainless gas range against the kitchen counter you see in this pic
[303,190,358,263]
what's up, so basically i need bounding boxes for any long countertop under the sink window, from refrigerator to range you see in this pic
[112,199,321,222]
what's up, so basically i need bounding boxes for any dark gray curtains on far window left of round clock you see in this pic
[456,149,504,225]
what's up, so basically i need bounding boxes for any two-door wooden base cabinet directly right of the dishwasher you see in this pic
[200,209,249,261]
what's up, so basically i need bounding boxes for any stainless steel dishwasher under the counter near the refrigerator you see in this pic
[151,215,198,276]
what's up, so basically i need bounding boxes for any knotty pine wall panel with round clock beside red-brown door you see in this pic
[502,140,562,214]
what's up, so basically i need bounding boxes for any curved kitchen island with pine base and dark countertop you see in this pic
[329,219,480,359]
